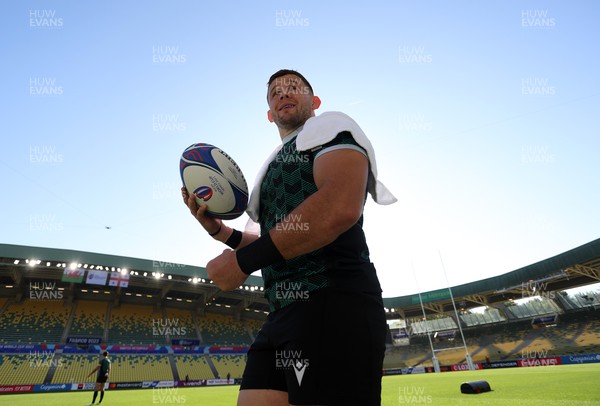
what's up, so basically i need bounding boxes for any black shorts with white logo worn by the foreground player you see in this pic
[240,289,387,406]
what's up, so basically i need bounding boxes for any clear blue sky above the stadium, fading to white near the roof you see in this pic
[0,0,600,297]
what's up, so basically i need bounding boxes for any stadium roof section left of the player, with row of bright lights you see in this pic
[0,244,269,317]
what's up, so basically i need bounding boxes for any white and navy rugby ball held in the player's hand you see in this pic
[179,143,248,220]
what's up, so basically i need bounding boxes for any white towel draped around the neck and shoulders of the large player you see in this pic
[246,111,397,226]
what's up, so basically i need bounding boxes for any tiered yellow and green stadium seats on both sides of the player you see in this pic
[0,299,600,385]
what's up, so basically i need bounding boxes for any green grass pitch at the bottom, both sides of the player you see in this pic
[0,364,600,406]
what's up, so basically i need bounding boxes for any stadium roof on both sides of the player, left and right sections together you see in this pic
[0,239,600,318]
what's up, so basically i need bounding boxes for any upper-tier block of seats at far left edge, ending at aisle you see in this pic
[0,299,70,344]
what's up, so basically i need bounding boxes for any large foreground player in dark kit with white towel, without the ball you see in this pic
[182,69,396,406]
